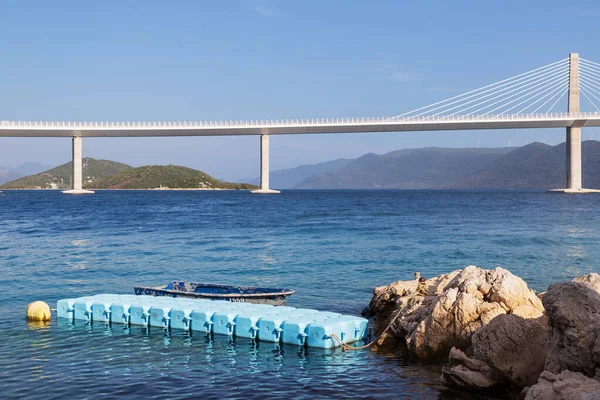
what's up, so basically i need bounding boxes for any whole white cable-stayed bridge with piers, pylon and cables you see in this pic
[0,53,600,194]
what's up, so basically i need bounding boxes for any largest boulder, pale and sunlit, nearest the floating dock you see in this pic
[367,266,543,359]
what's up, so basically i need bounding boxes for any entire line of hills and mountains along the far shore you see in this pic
[0,140,600,189]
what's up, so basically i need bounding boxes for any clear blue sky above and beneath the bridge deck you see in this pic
[0,0,600,180]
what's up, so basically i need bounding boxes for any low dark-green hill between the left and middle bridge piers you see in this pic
[88,165,257,190]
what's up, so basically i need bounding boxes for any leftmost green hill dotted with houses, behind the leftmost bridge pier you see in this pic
[0,158,133,189]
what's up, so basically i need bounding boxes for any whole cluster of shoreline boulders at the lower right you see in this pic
[364,266,600,400]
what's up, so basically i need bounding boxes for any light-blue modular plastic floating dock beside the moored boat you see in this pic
[56,294,367,349]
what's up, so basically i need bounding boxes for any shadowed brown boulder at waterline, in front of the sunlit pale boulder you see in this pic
[441,314,547,390]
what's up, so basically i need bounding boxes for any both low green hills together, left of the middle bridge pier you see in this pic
[0,158,256,189]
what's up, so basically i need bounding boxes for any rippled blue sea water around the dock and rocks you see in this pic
[0,191,600,399]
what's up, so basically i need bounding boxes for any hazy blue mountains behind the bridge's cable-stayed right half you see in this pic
[247,141,600,189]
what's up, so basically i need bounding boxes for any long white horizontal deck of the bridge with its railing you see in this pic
[0,113,600,137]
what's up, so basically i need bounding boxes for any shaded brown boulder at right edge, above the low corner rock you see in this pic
[543,282,600,377]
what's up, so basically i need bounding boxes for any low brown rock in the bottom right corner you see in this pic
[525,371,600,400]
